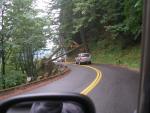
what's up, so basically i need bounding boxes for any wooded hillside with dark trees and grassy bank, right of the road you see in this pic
[52,0,143,68]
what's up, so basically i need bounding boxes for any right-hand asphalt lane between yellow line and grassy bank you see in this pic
[89,65,140,113]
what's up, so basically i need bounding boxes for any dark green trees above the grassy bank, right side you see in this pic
[50,0,143,47]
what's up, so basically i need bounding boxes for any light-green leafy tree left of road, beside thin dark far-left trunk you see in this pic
[4,0,46,77]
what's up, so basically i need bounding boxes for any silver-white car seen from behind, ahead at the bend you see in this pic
[75,53,91,64]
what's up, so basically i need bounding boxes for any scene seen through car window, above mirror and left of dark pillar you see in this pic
[0,0,143,113]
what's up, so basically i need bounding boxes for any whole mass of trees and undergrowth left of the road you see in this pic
[0,0,60,90]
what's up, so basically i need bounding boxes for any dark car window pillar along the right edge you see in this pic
[137,0,150,113]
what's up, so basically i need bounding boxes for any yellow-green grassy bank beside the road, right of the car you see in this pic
[90,40,141,69]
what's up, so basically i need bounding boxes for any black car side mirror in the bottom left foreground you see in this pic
[0,93,95,113]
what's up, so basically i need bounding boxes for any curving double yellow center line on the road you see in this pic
[66,62,102,95]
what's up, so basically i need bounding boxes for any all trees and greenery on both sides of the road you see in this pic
[0,0,143,89]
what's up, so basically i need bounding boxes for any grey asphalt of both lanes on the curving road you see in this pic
[5,64,139,113]
